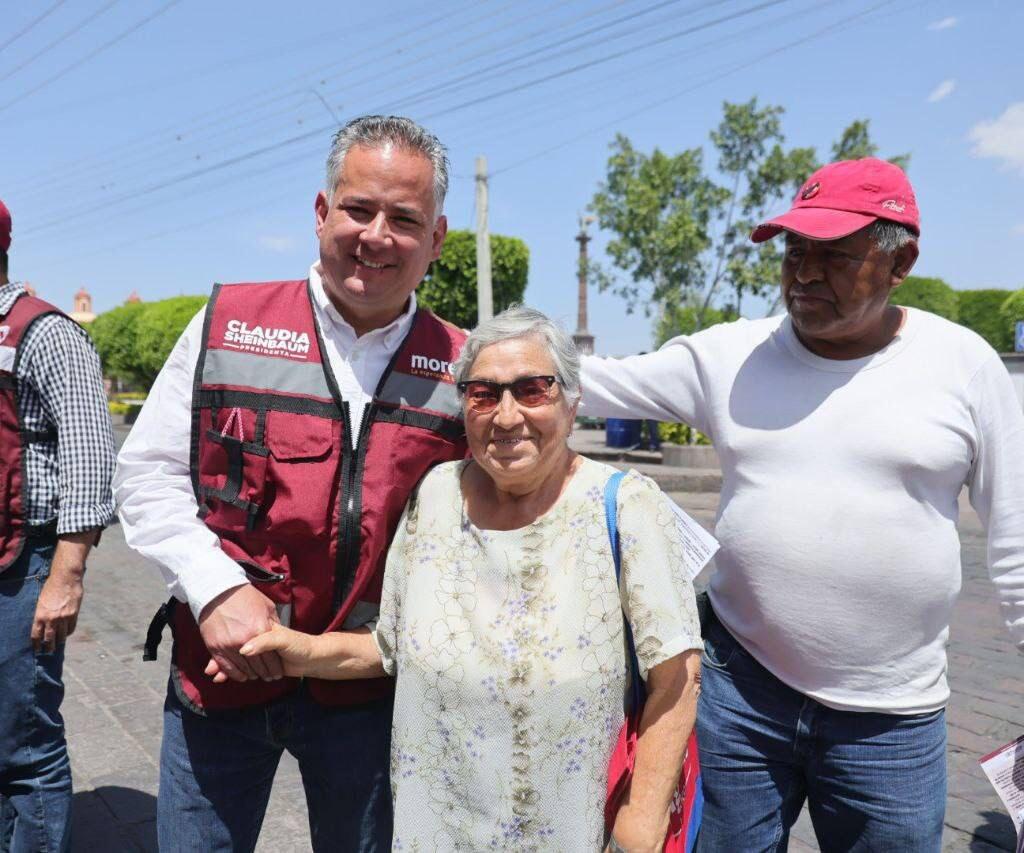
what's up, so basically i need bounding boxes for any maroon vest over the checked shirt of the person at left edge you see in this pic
[0,294,62,571]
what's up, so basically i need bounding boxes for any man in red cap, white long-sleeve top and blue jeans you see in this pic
[583,158,1024,853]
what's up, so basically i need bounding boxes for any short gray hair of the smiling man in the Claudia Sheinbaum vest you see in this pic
[327,116,449,216]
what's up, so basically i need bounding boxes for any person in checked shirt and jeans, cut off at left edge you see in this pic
[0,202,115,851]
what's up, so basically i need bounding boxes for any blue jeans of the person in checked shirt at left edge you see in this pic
[0,540,71,853]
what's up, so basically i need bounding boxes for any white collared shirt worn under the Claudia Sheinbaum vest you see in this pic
[114,263,416,620]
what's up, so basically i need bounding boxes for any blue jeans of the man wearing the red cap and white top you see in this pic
[697,617,946,853]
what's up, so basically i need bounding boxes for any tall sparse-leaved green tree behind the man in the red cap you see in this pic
[588,98,905,329]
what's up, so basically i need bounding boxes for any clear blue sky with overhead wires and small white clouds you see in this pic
[0,0,1024,353]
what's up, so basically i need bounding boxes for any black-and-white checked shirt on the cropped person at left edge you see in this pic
[0,282,114,535]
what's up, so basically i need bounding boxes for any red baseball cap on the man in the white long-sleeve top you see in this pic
[751,157,921,243]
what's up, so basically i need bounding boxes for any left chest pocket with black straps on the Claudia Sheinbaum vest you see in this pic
[200,409,269,530]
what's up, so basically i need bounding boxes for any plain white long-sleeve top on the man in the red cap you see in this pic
[583,308,1024,714]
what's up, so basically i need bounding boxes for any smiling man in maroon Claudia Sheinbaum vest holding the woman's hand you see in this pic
[115,116,466,851]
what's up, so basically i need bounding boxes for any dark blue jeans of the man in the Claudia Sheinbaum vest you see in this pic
[157,684,392,853]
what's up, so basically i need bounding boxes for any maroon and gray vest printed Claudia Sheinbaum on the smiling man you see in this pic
[171,282,466,711]
